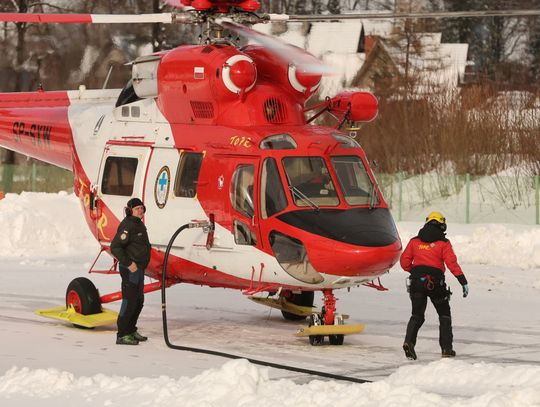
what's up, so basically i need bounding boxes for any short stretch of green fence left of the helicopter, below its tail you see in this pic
[0,163,73,193]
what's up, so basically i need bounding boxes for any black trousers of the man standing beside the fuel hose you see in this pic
[117,266,144,338]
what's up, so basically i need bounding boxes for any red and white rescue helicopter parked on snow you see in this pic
[0,0,401,344]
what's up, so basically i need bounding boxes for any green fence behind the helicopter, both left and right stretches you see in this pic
[0,163,540,225]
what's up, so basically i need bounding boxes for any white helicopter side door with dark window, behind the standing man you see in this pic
[96,145,150,240]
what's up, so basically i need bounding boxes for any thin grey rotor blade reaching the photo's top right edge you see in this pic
[268,9,540,21]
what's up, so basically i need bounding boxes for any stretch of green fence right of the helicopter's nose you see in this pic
[377,173,540,225]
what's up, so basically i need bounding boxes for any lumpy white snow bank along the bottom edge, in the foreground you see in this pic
[0,360,540,407]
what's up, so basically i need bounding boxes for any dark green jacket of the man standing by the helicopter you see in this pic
[111,216,151,270]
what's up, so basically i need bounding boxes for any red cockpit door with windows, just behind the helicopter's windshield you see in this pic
[229,157,260,248]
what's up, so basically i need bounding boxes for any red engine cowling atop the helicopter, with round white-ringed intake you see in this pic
[157,44,305,126]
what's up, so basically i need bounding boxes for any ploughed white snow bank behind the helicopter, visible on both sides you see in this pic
[0,192,540,270]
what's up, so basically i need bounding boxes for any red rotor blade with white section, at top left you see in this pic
[0,13,174,24]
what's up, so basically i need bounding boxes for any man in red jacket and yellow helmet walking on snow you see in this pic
[399,212,469,360]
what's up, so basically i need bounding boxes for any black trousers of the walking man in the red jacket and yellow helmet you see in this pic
[405,278,453,350]
